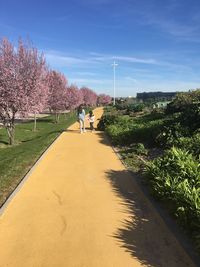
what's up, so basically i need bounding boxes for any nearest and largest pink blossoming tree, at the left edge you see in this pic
[0,39,48,144]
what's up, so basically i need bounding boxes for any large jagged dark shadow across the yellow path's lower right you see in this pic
[106,170,195,267]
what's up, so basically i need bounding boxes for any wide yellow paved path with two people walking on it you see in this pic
[0,108,194,267]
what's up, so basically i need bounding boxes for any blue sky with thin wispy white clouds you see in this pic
[0,0,200,96]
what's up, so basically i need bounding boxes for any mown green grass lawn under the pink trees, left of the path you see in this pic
[0,114,76,206]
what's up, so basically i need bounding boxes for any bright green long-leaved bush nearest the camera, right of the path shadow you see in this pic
[146,147,200,249]
